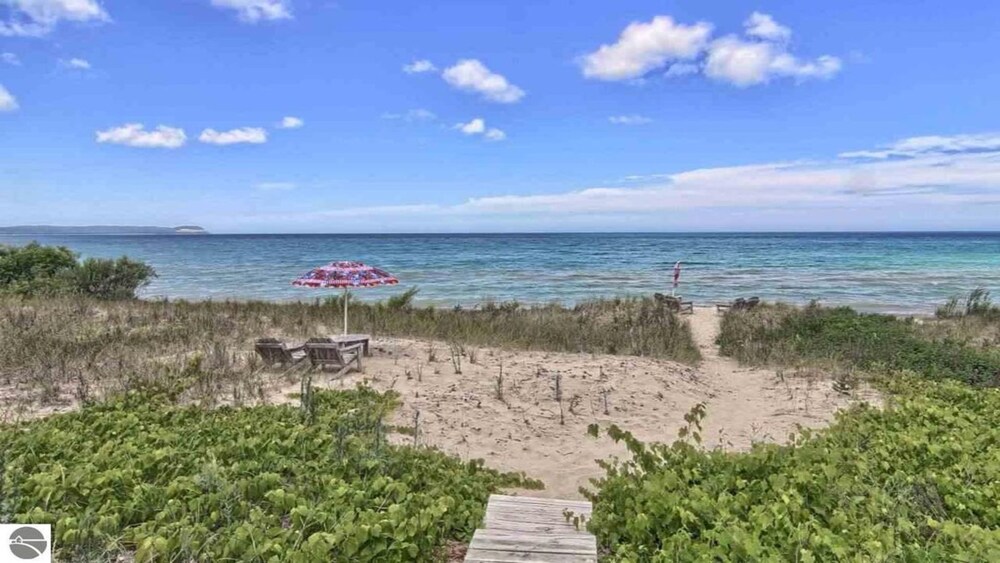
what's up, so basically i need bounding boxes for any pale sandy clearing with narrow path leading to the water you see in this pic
[302,308,869,498]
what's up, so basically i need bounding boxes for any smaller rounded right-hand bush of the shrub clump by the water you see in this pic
[65,256,156,299]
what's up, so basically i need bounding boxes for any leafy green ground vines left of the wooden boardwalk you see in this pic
[0,388,531,562]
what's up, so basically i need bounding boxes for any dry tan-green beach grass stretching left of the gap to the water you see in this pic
[0,295,699,412]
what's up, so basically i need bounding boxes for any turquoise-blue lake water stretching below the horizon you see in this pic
[0,233,1000,313]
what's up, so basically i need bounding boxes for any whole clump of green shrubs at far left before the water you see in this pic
[0,242,156,299]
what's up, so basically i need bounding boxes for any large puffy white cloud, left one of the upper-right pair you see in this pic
[581,16,712,81]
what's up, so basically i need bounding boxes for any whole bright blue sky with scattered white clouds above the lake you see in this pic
[0,0,1000,232]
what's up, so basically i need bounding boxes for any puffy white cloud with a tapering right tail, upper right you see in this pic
[705,35,842,87]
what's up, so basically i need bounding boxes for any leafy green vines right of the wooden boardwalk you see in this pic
[587,377,1000,562]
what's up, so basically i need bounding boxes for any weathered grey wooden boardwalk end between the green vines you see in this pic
[465,495,597,563]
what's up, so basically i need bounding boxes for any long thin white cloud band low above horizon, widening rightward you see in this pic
[260,131,1000,228]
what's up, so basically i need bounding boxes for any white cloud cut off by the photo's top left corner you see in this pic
[0,0,111,37]
